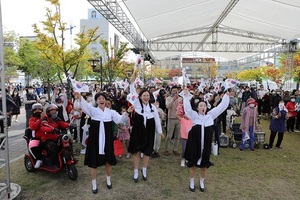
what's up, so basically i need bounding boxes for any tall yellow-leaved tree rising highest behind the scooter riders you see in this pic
[33,0,100,97]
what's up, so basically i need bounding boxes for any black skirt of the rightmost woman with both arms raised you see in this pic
[184,124,213,168]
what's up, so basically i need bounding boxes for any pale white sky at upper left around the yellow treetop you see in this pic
[0,0,92,36]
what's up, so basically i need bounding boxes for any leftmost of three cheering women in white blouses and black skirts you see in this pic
[74,93,130,194]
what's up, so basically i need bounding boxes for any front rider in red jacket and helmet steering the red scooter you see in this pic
[41,104,70,166]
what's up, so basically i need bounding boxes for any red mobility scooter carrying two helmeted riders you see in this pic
[23,128,78,180]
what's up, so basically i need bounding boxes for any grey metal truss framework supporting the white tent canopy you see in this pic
[87,0,289,62]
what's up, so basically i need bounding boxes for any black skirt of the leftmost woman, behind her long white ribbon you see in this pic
[84,120,117,168]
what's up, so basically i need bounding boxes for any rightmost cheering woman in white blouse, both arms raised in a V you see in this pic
[183,90,232,192]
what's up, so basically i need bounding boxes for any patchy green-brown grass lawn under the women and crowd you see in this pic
[0,116,300,200]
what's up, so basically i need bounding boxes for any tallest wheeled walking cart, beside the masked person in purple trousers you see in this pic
[229,115,249,149]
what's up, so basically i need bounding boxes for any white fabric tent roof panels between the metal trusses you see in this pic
[123,0,300,60]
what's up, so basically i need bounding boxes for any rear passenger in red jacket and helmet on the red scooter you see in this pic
[28,103,45,169]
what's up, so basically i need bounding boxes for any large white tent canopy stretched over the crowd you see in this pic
[88,0,300,60]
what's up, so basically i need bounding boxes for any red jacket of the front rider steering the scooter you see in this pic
[41,116,70,142]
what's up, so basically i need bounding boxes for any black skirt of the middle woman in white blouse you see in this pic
[128,113,155,156]
